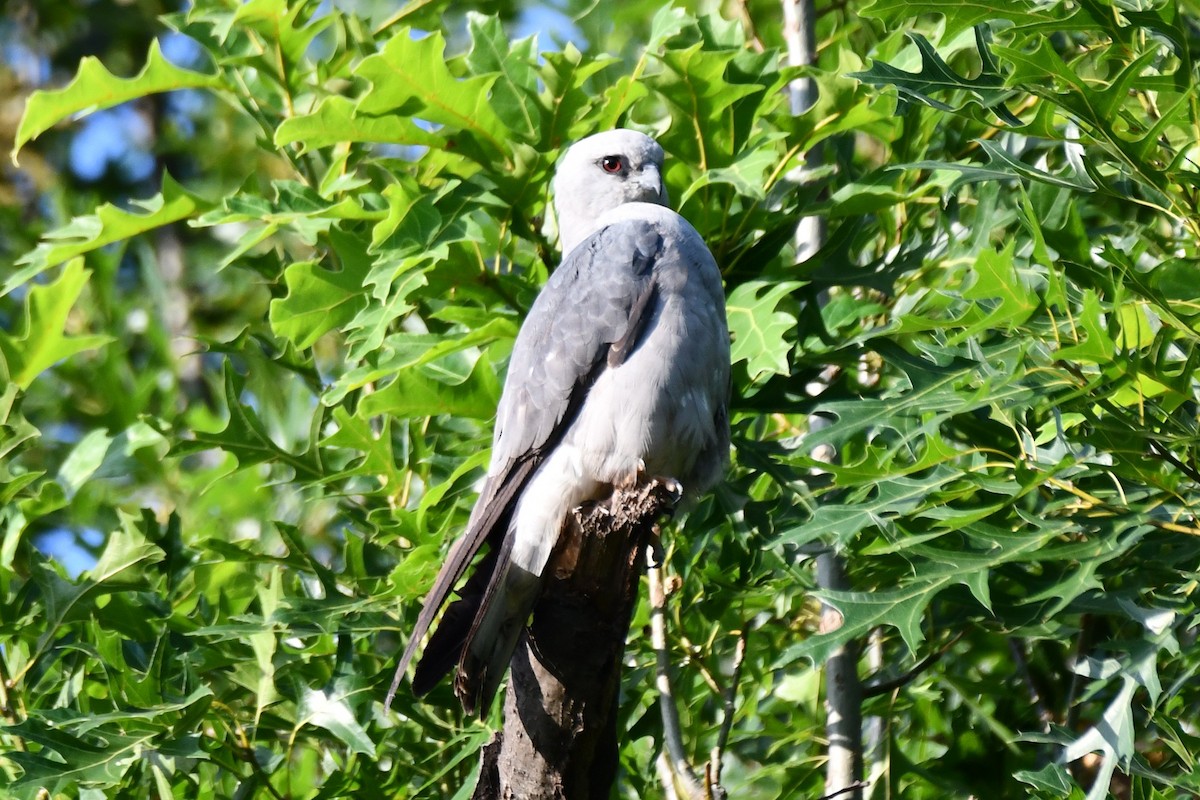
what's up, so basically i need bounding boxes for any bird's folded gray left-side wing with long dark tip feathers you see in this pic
[389,222,664,708]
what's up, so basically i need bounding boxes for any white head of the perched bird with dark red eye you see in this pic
[554,128,667,255]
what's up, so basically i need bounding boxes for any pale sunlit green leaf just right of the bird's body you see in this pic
[725,281,802,383]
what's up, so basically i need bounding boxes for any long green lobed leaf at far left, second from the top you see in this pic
[8,173,212,296]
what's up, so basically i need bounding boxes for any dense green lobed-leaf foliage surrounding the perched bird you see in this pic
[0,0,1200,799]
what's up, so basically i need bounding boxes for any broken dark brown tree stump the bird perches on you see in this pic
[473,480,677,800]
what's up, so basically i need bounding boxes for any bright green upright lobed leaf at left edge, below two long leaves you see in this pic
[0,258,113,389]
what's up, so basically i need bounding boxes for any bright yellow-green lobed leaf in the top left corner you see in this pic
[11,40,221,166]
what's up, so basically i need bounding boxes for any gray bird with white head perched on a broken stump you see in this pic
[388,130,730,714]
